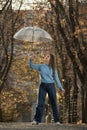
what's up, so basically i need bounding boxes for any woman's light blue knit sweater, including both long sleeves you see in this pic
[29,59,63,90]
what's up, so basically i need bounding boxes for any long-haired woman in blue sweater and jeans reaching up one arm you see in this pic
[29,54,65,125]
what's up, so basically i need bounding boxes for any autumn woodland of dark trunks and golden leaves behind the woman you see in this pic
[0,0,87,123]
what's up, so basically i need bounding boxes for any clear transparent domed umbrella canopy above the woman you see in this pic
[13,27,53,42]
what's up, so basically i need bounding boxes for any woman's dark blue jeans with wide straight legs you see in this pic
[34,83,59,122]
